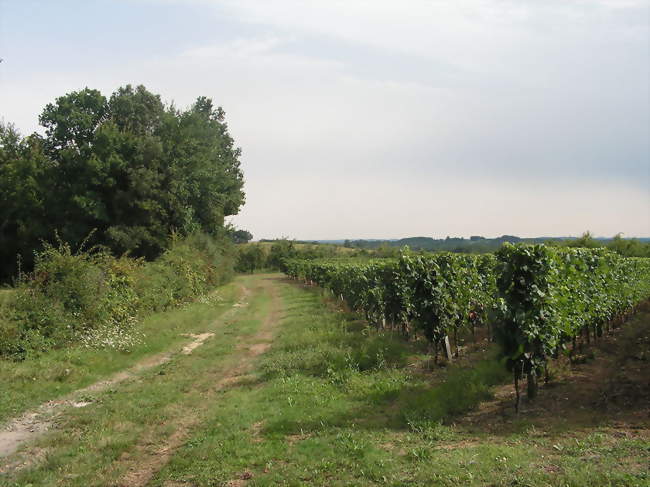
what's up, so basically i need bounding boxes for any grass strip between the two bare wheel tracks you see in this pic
[0,276,269,486]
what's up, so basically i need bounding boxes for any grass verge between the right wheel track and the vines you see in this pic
[152,280,649,486]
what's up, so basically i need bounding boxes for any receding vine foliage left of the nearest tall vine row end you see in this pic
[287,252,495,350]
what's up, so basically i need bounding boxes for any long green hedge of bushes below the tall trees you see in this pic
[0,234,234,359]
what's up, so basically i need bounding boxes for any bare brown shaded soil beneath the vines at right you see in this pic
[456,305,650,438]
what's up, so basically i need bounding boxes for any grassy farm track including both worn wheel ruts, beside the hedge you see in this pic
[0,275,281,485]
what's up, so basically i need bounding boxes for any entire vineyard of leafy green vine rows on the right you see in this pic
[286,244,650,407]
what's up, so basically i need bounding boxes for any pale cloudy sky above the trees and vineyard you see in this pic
[0,0,650,239]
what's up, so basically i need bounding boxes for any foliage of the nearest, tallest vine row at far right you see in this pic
[497,244,650,400]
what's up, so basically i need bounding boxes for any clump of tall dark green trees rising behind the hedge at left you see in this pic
[0,85,244,280]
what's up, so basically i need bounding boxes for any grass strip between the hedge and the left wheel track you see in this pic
[0,284,240,424]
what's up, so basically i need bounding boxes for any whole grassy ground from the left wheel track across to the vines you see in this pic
[0,275,650,487]
